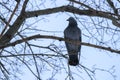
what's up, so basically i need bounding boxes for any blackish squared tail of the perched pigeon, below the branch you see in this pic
[69,54,79,66]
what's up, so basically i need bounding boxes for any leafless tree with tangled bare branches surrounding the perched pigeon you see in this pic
[0,0,120,80]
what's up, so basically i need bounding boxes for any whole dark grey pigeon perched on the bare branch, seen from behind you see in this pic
[64,17,81,66]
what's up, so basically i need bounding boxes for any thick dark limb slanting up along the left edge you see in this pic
[0,0,29,45]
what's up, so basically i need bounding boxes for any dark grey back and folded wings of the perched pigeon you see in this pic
[64,28,81,52]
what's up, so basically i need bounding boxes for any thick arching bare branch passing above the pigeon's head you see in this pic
[26,5,120,27]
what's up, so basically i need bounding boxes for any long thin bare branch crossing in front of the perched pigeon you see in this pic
[0,34,120,54]
